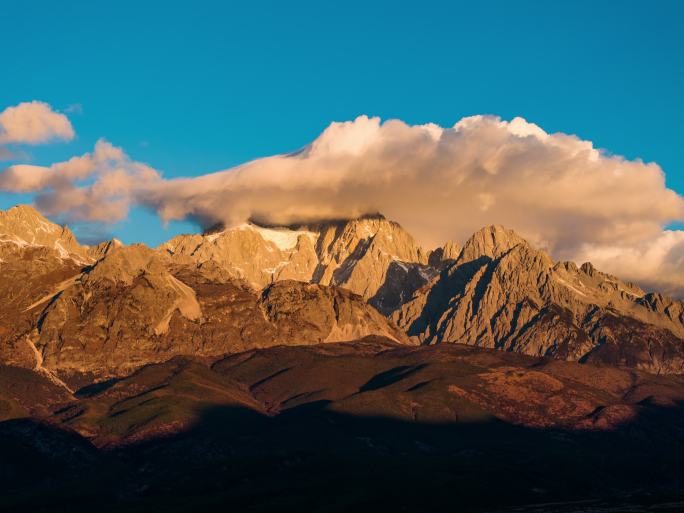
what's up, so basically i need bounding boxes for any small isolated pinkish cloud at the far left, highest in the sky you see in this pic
[0,101,74,144]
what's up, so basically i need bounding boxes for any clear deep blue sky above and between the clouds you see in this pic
[0,0,684,244]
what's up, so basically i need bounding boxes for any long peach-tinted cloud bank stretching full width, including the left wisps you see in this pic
[0,109,684,295]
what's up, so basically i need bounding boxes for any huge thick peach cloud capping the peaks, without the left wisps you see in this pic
[146,116,684,246]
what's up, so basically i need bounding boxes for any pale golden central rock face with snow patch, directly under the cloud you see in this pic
[160,215,434,304]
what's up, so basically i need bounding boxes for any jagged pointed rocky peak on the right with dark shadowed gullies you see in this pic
[392,226,684,373]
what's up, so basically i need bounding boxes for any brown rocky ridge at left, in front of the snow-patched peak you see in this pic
[6,245,408,379]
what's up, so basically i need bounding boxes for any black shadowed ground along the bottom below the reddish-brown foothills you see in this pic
[0,394,684,513]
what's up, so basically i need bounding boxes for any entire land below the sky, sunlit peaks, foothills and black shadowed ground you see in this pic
[0,205,684,512]
